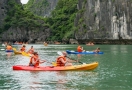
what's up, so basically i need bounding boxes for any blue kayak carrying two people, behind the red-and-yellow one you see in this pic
[66,50,104,54]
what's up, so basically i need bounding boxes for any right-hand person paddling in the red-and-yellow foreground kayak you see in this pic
[56,52,78,66]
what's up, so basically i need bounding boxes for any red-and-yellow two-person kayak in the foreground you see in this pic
[12,62,98,71]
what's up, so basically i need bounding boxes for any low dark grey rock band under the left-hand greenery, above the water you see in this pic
[1,27,50,43]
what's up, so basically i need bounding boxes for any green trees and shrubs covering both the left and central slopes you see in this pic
[0,0,78,41]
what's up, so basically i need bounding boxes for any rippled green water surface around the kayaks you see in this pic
[0,44,132,90]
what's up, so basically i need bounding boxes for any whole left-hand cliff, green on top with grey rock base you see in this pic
[0,0,50,43]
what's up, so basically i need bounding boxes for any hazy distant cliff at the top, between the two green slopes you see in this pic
[26,0,58,17]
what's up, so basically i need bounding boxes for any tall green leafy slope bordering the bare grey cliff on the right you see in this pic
[46,0,78,40]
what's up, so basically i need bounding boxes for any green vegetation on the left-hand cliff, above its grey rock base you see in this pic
[3,0,49,30]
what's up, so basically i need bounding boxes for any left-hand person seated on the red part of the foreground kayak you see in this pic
[29,52,46,67]
